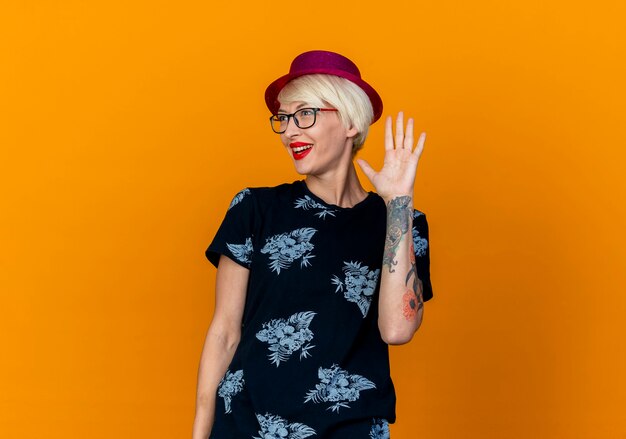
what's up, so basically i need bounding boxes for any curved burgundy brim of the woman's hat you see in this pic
[265,68,383,123]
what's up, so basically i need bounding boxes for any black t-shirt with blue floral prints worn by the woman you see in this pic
[206,181,432,439]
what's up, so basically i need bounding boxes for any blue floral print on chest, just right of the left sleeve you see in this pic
[261,227,317,274]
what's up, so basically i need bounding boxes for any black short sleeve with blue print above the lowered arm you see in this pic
[205,188,254,268]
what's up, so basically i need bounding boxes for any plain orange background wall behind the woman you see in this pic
[0,0,626,439]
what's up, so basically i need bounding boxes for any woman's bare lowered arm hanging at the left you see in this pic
[192,255,250,439]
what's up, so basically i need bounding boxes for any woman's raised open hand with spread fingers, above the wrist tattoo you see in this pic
[357,112,426,201]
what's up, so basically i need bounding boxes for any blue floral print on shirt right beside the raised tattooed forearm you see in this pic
[331,262,380,318]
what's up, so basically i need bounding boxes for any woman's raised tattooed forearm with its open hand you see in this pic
[357,112,426,344]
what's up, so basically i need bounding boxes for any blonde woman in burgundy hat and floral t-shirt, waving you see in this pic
[193,51,432,439]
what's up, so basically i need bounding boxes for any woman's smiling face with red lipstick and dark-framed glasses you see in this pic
[278,102,357,176]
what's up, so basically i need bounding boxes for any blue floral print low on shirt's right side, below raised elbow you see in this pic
[304,364,376,412]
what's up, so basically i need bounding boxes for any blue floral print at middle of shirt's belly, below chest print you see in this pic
[256,311,315,367]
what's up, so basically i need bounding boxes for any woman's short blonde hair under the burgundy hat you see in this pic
[278,74,374,155]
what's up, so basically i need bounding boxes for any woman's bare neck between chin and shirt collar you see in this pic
[305,163,367,207]
